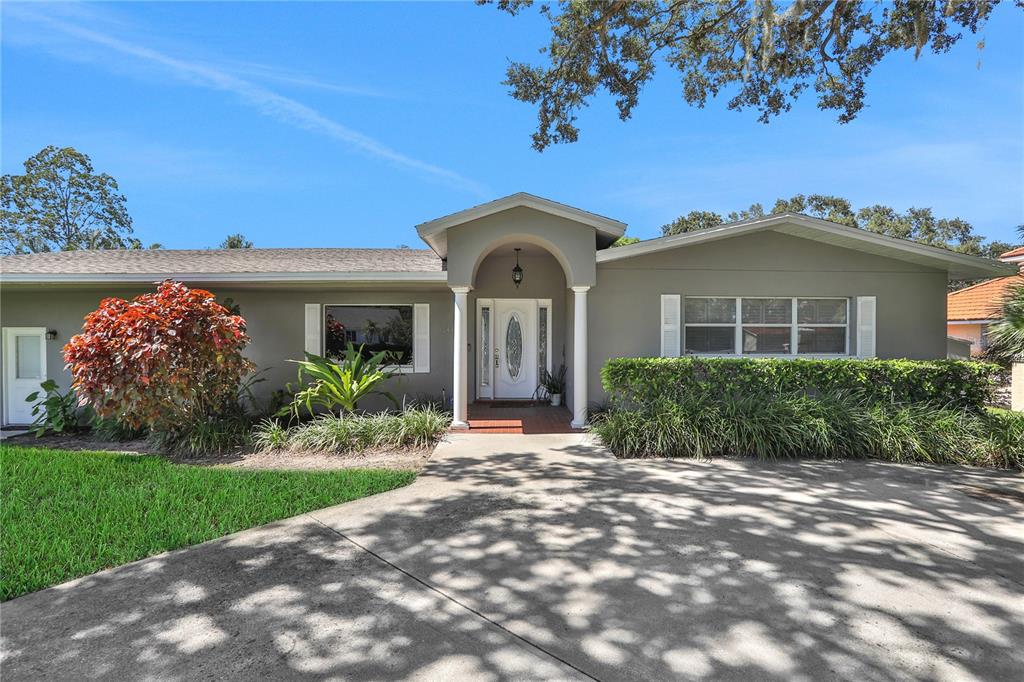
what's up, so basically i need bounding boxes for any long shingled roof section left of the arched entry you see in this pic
[0,249,446,283]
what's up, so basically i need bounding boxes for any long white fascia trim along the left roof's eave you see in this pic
[0,271,447,284]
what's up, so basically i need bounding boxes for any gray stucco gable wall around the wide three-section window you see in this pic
[588,231,946,400]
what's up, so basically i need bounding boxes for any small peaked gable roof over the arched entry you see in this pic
[416,191,626,257]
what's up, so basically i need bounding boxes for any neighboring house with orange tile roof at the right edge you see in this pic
[946,247,1024,355]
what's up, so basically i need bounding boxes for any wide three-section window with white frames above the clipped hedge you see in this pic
[683,296,850,355]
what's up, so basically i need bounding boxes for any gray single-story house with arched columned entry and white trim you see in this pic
[0,194,1013,426]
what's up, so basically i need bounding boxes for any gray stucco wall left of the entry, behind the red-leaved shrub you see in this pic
[0,287,453,414]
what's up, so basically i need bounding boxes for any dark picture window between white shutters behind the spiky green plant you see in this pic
[324,305,414,367]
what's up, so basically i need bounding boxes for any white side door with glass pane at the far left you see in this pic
[3,327,46,424]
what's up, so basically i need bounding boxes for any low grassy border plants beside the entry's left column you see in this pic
[253,408,451,453]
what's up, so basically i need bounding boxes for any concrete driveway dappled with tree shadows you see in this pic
[2,434,1024,682]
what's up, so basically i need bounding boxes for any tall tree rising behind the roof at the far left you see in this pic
[0,145,149,253]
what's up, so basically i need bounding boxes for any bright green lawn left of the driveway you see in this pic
[0,445,416,601]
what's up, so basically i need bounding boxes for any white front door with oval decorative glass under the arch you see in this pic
[495,298,538,398]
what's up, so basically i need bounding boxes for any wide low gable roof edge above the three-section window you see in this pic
[597,213,1017,280]
